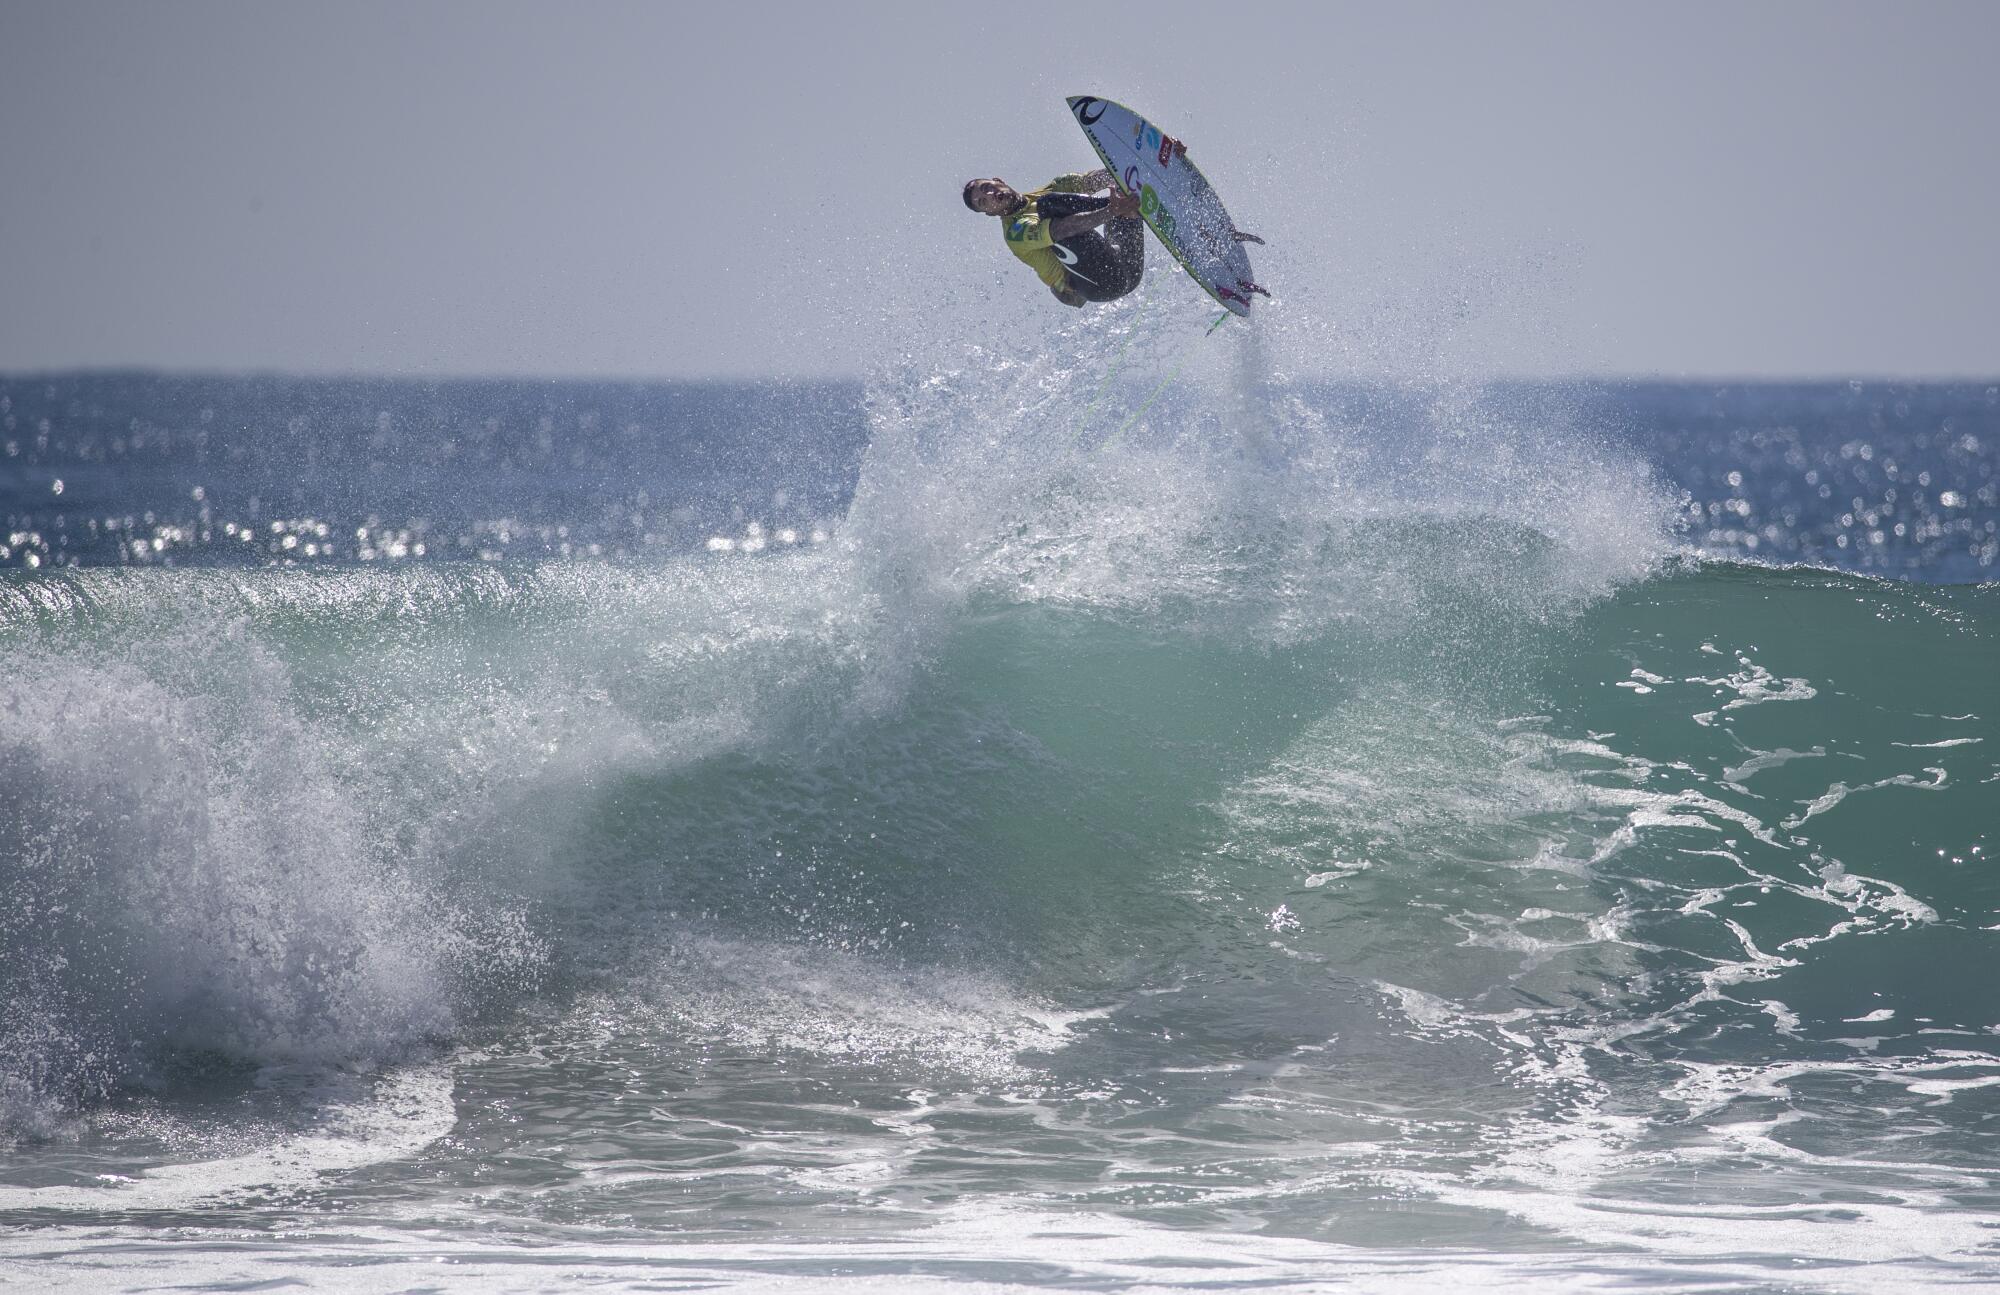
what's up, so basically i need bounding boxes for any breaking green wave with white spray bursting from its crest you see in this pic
[0,312,2000,1155]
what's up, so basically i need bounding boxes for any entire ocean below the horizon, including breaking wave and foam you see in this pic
[0,310,2000,1291]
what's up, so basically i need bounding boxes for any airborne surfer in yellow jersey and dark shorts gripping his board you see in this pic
[964,170,1146,306]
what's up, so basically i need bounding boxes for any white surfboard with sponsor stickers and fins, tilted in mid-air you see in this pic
[1068,94,1268,316]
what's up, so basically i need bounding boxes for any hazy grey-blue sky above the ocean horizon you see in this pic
[0,0,2000,376]
